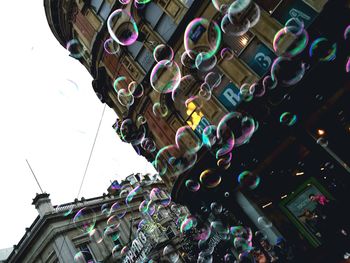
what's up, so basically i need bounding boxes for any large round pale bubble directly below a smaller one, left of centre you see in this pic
[150,60,181,93]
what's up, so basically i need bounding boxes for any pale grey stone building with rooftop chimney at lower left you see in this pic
[4,174,188,263]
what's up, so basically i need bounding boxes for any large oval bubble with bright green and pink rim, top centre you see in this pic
[184,18,222,60]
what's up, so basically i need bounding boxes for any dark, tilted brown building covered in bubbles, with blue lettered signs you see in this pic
[44,0,350,262]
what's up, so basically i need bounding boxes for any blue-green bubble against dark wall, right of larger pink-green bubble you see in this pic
[309,37,337,61]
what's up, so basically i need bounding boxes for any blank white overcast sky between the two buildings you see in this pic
[0,0,155,248]
